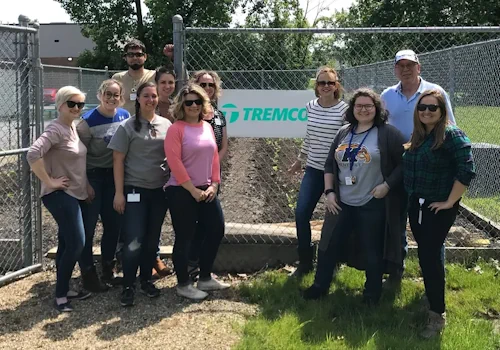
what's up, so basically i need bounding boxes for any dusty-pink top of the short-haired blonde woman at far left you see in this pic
[27,119,88,200]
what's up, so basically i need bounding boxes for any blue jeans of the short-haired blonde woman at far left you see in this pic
[42,191,85,298]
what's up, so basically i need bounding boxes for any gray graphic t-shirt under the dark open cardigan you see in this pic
[335,127,384,207]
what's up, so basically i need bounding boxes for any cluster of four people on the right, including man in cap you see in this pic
[290,50,475,338]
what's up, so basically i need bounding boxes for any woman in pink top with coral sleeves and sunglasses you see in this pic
[165,84,229,300]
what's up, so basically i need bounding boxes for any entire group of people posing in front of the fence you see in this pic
[28,40,474,337]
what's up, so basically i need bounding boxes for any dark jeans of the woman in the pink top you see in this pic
[167,186,225,286]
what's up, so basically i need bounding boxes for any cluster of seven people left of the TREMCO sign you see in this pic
[27,40,230,312]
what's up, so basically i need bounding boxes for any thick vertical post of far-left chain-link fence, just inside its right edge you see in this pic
[18,15,33,267]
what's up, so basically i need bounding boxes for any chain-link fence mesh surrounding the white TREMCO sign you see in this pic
[182,28,500,252]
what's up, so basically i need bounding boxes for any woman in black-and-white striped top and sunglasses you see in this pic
[288,67,348,278]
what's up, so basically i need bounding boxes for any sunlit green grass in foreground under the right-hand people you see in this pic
[236,259,500,350]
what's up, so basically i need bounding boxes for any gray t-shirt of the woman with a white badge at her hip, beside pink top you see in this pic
[108,115,172,189]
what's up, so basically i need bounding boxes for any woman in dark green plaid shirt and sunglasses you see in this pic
[403,90,475,338]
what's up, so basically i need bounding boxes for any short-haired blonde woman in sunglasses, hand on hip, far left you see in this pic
[27,86,91,312]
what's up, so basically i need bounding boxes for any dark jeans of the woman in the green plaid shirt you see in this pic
[409,197,459,314]
